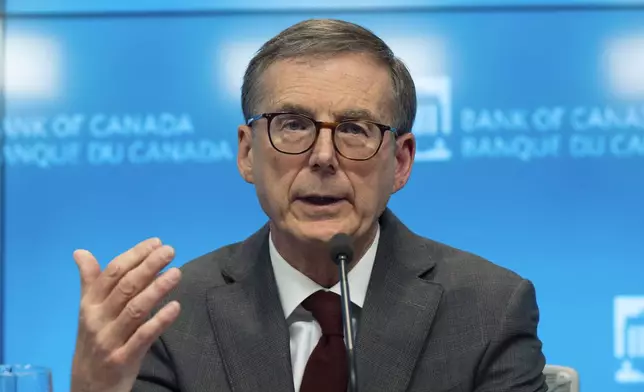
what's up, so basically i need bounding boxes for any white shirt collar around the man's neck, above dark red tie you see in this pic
[269,226,380,318]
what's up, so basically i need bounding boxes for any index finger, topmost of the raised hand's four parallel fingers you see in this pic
[88,238,161,302]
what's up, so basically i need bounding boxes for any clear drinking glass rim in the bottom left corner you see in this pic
[0,365,53,392]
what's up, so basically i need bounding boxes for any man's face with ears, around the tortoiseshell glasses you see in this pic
[238,54,415,245]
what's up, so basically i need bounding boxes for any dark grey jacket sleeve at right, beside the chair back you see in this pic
[475,280,548,392]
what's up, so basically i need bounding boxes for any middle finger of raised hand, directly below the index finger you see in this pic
[103,245,174,318]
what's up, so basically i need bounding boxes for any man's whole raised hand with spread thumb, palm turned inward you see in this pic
[71,238,181,392]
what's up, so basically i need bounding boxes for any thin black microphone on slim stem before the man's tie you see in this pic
[329,233,358,392]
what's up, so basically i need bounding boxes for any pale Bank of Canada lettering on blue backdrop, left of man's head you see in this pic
[0,112,234,169]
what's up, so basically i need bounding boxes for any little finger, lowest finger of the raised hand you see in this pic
[116,301,181,361]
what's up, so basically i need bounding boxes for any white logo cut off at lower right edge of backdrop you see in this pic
[614,296,644,384]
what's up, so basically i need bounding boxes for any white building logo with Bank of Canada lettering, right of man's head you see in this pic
[412,71,644,163]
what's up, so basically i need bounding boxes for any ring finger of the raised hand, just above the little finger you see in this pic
[109,268,181,344]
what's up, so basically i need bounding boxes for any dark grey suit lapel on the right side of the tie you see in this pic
[356,210,443,392]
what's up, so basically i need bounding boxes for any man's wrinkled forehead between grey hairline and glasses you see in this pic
[254,54,393,124]
